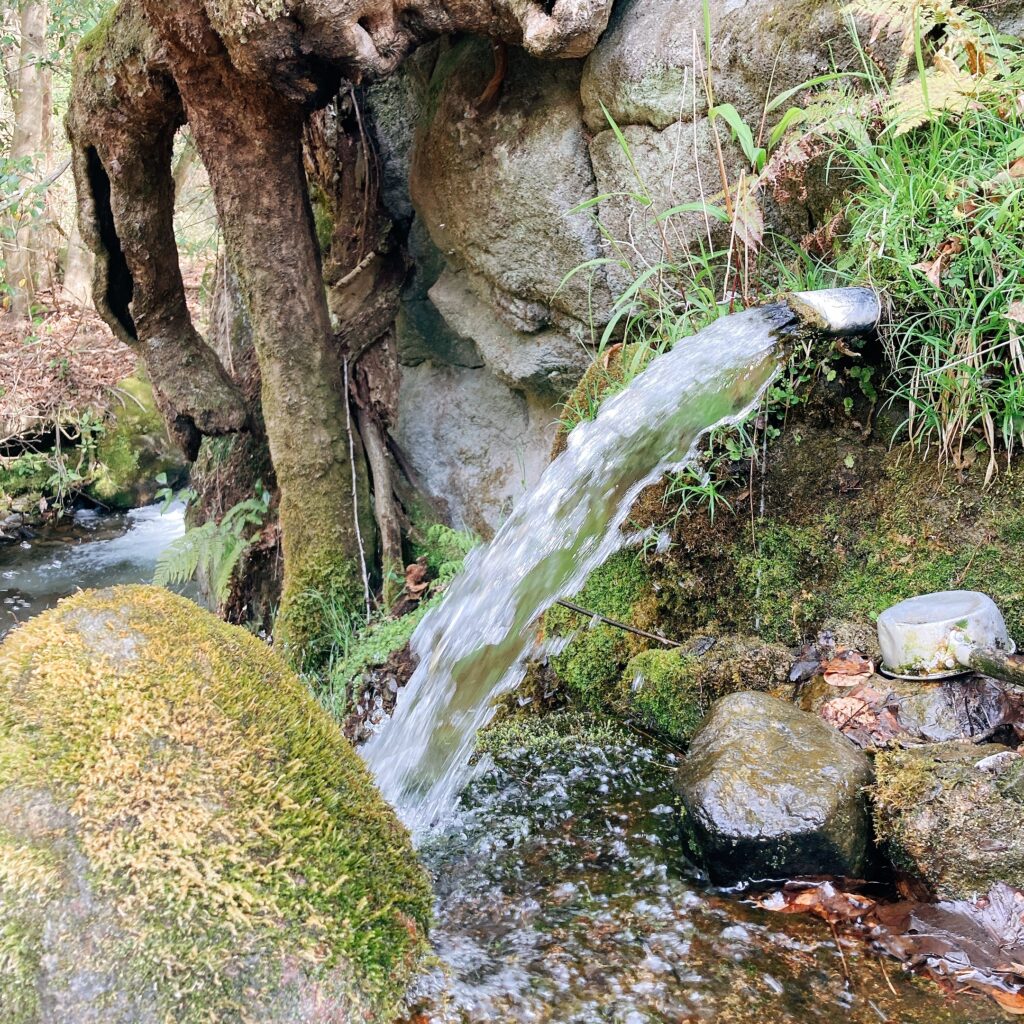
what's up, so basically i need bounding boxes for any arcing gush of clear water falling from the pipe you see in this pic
[364,306,793,836]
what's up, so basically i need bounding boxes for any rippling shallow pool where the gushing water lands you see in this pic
[408,721,1000,1024]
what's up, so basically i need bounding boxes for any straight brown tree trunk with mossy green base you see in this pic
[142,2,372,660]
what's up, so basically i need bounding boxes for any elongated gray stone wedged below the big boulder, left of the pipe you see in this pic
[429,270,592,399]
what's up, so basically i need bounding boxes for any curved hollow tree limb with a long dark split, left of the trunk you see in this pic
[68,4,247,459]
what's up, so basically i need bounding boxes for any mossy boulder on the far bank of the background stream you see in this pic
[86,373,186,509]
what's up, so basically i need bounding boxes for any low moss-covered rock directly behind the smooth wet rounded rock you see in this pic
[618,636,792,743]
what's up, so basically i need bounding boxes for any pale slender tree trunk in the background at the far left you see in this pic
[4,0,51,318]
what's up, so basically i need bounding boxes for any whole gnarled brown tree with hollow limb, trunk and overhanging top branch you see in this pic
[69,0,611,660]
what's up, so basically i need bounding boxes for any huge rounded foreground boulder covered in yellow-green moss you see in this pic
[0,587,430,1024]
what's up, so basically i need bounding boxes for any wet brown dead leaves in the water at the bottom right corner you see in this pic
[754,879,1024,1015]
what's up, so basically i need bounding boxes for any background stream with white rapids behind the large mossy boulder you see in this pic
[0,503,185,637]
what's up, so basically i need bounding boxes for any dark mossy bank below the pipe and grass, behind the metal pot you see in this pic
[634,422,1024,645]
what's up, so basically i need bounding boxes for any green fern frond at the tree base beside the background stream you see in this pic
[153,490,270,604]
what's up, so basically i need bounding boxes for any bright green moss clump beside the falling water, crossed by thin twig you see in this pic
[544,551,650,709]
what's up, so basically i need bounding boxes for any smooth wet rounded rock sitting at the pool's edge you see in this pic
[678,693,870,884]
